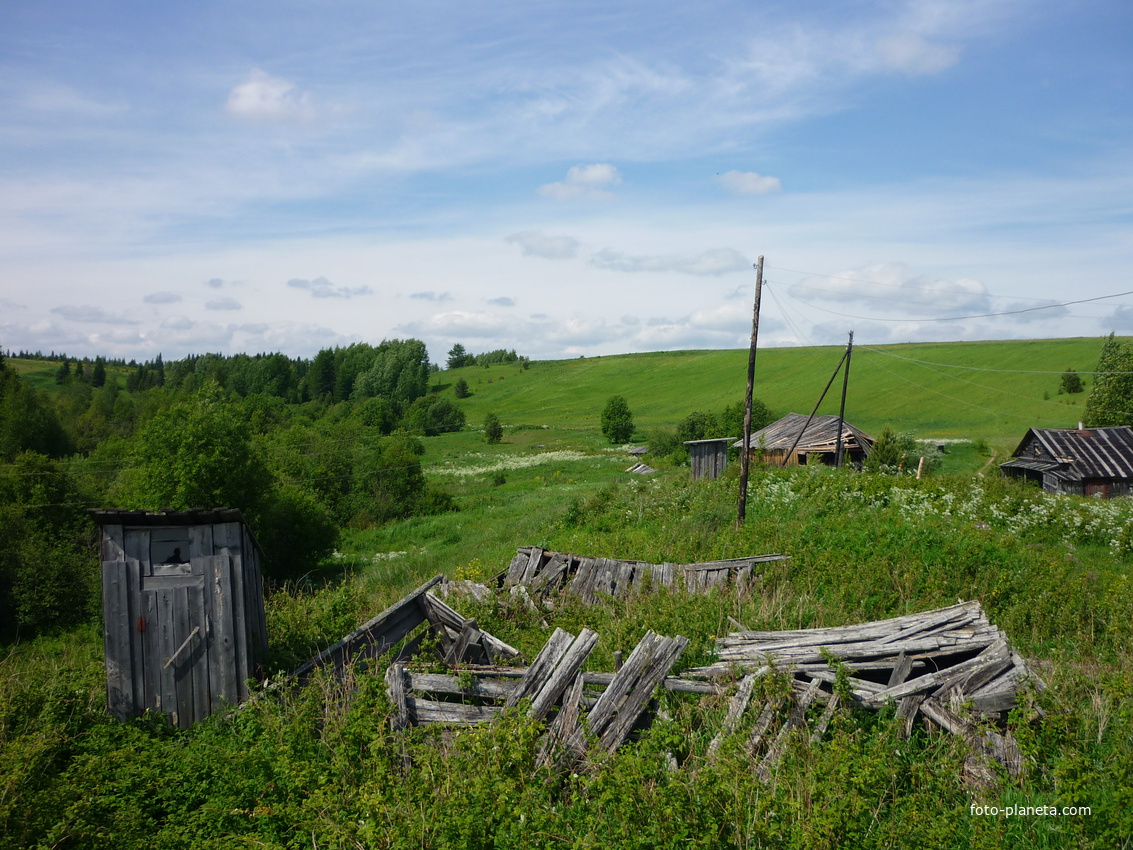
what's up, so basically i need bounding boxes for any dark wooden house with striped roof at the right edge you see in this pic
[999,425,1133,499]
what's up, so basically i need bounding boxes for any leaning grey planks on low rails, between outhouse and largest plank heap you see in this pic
[385,629,697,763]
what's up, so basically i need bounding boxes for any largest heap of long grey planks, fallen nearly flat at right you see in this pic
[685,602,1045,775]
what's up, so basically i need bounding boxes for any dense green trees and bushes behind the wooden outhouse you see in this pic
[0,339,505,635]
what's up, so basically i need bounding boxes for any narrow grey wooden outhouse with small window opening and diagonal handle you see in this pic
[92,508,267,729]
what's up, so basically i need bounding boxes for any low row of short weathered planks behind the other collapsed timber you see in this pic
[496,546,786,605]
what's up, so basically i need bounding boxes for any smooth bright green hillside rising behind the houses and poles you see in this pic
[437,339,1102,447]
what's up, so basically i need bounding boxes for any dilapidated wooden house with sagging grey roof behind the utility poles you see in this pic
[735,414,874,466]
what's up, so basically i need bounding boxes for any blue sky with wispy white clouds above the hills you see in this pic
[0,0,1133,363]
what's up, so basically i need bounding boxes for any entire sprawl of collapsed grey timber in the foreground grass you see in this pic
[291,546,1045,781]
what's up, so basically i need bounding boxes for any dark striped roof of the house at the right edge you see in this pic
[1000,425,1133,481]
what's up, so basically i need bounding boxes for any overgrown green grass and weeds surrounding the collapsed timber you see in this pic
[0,453,1133,848]
